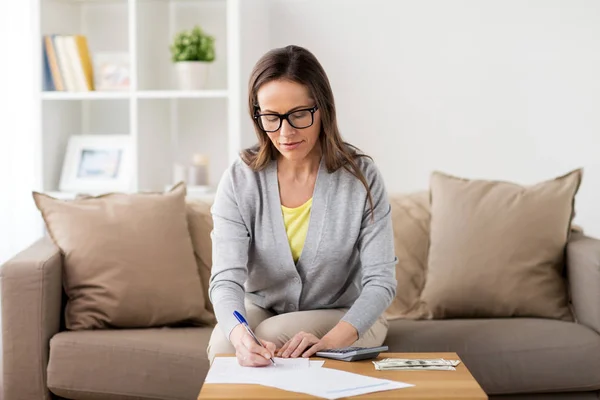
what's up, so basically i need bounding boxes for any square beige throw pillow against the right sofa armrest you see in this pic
[421,170,582,321]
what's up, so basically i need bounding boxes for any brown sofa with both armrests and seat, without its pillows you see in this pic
[1,192,600,400]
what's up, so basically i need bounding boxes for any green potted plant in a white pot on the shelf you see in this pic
[170,25,215,90]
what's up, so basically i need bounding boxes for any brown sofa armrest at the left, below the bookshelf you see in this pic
[0,237,62,400]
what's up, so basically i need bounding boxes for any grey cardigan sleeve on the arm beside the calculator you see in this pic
[342,163,398,337]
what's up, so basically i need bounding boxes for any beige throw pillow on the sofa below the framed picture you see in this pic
[33,184,210,330]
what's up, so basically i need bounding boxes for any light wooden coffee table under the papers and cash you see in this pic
[198,353,487,400]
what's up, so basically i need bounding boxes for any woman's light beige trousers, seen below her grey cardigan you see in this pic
[206,300,388,364]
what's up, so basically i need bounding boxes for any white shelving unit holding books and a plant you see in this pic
[34,0,269,202]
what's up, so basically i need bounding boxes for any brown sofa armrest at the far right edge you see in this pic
[567,234,600,333]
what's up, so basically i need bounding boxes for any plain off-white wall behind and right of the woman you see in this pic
[269,0,600,236]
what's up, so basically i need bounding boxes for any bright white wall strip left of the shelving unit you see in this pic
[0,1,42,264]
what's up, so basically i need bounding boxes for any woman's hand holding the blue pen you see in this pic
[229,324,276,367]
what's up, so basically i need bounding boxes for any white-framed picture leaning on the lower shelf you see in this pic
[59,135,133,194]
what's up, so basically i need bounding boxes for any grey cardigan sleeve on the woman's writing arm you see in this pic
[209,168,250,339]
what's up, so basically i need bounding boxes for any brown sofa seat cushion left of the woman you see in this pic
[48,327,212,400]
